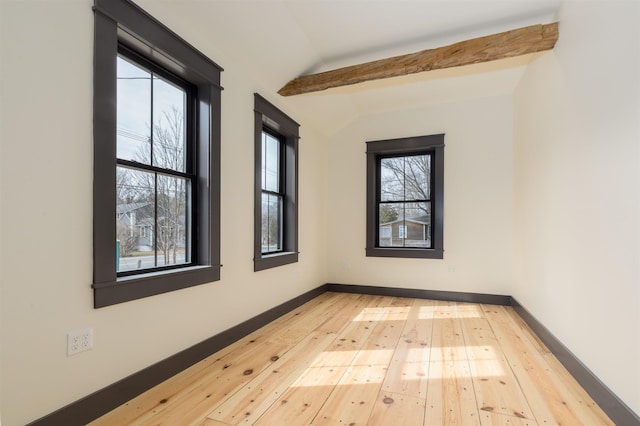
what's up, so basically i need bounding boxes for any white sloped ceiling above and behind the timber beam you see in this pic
[141,0,561,134]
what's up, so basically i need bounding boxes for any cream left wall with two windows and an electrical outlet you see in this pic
[0,0,327,426]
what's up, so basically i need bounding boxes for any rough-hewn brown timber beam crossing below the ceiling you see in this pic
[278,22,558,96]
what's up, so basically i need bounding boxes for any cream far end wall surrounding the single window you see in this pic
[328,96,513,294]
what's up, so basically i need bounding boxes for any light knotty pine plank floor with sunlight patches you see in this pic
[91,293,613,426]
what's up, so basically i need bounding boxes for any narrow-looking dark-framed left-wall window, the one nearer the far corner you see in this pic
[254,94,299,271]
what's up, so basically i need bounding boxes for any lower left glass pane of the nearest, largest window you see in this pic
[116,167,155,272]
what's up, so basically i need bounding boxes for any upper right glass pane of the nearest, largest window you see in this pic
[153,75,187,172]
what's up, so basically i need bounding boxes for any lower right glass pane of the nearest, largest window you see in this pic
[157,175,190,266]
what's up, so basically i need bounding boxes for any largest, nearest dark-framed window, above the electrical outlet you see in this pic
[93,0,222,307]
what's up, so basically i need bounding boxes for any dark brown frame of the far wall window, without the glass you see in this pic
[366,134,444,259]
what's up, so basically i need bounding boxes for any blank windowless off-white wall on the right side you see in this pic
[513,1,640,413]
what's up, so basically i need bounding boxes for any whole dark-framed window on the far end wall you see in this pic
[367,135,444,259]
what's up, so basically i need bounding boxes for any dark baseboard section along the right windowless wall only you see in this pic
[511,297,640,426]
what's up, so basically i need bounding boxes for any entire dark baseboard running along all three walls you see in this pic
[29,283,640,426]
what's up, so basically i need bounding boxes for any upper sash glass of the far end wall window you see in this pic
[380,154,431,201]
